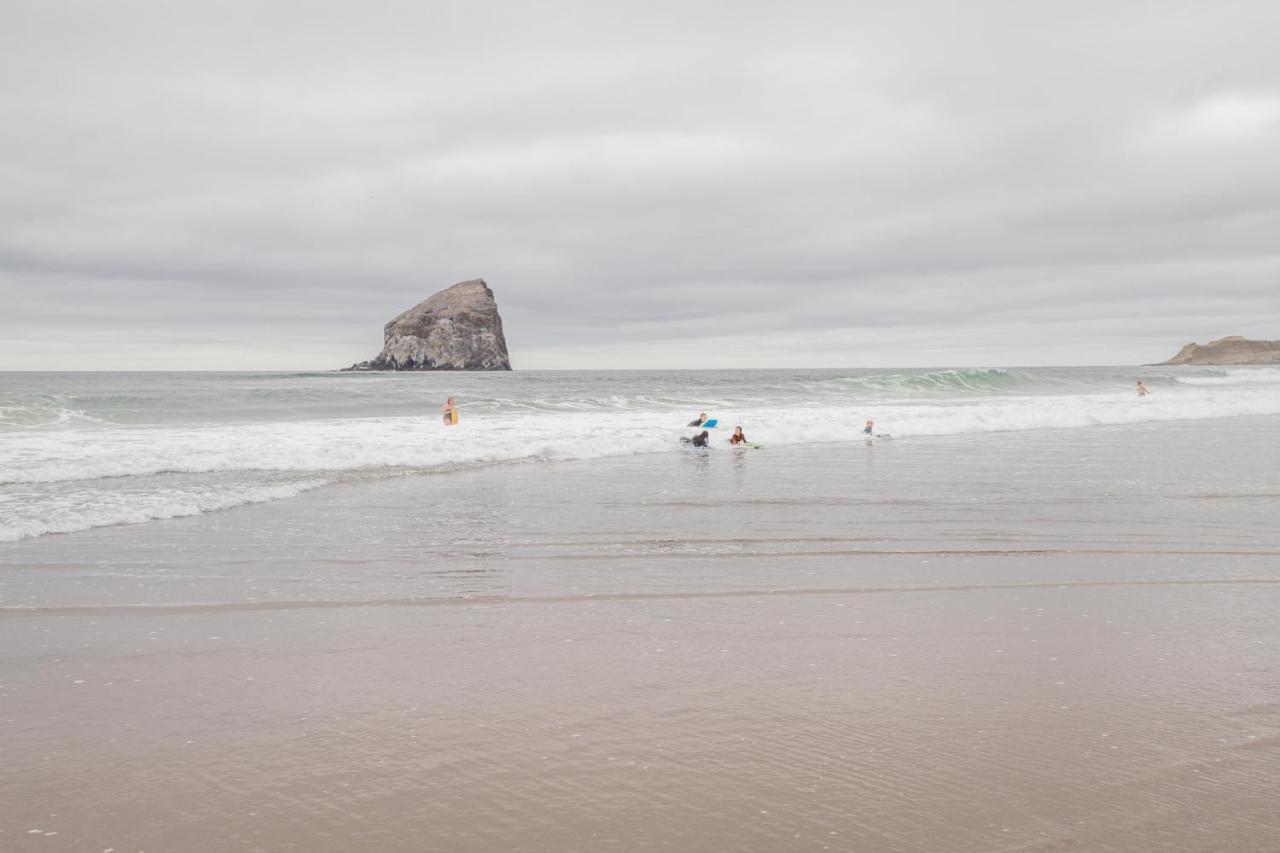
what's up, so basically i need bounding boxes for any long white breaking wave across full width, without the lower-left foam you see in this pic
[0,386,1280,484]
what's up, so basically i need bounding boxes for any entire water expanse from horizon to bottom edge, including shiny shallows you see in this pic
[0,368,1280,853]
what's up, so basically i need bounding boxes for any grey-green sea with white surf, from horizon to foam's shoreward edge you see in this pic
[0,368,1280,542]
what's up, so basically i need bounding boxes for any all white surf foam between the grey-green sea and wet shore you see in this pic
[0,369,1280,540]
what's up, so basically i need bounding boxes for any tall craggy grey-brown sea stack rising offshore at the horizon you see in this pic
[347,278,511,370]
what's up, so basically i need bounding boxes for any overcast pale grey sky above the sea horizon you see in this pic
[0,0,1280,370]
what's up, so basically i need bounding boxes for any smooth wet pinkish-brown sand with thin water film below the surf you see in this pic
[0,421,1280,853]
